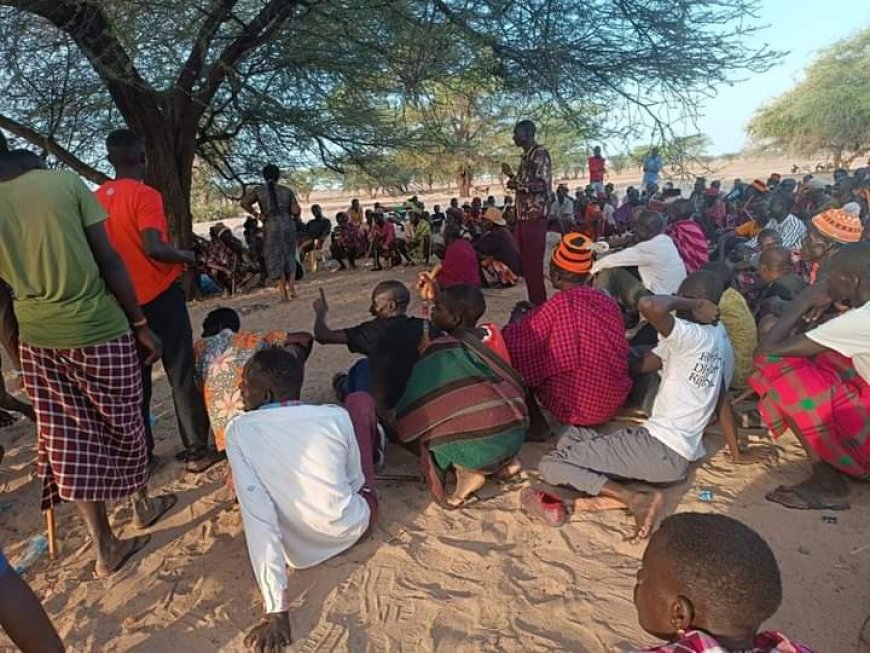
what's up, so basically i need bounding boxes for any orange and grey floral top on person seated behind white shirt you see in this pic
[194,329,287,451]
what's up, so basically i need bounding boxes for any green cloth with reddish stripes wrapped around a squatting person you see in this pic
[396,333,529,482]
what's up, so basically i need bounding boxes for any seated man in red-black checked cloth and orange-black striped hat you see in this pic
[504,233,631,426]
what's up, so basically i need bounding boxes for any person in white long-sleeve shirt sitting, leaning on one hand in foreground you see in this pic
[227,349,377,651]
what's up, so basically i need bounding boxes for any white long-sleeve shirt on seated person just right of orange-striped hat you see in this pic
[592,234,686,295]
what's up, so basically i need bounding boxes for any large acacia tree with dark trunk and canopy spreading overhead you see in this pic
[0,0,776,241]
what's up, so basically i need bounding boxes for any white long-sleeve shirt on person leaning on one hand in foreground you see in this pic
[227,404,370,612]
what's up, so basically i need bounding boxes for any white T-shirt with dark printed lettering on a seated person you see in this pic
[644,318,734,461]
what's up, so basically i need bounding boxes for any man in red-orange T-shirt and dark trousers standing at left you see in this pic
[96,129,219,473]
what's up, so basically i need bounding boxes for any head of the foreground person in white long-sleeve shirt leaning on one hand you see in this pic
[242,348,305,410]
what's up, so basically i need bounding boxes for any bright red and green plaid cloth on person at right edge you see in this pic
[749,351,870,479]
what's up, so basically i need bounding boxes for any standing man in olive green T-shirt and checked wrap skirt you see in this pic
[0,151,175,577]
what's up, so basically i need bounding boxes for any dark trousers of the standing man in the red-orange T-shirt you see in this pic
[142,284,210,458]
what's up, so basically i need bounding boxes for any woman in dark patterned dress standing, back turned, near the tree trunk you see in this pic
[241,163,302,302]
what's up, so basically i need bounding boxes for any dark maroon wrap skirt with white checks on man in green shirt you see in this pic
[21,335,148,510]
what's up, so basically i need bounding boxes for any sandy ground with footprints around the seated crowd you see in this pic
[0,155,870,653]
